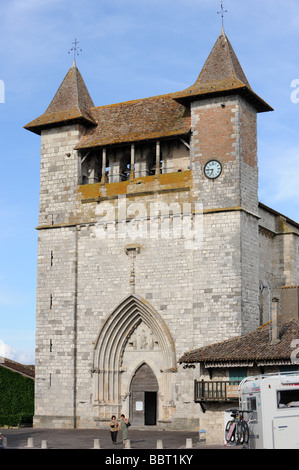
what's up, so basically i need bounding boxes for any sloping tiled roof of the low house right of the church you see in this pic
[179,320,299,363]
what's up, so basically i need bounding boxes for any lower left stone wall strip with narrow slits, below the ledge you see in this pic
[35,228,77,427]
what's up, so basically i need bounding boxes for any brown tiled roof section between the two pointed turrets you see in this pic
[76,94,191,149]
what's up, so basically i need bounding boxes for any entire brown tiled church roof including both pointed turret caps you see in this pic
[25,31,272,141]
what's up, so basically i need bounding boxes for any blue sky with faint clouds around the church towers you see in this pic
[0,0,299,363]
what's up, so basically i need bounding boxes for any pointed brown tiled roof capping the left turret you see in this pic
[25,61,96,134]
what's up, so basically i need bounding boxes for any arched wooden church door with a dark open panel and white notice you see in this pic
[130,364,159,426]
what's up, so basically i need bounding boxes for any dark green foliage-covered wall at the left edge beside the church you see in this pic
[0,367,34,426]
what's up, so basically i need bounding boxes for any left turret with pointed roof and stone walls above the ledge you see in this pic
[25,61,96,226]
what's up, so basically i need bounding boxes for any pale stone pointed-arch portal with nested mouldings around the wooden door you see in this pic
[92,294,176,424]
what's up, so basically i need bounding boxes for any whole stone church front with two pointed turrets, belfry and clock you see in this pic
[25,30,271,430]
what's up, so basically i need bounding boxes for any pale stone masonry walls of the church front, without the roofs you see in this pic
[35,93,276,429]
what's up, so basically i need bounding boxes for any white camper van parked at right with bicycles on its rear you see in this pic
[239,372,299,449]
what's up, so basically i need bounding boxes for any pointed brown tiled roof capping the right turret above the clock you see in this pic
[174,28,272,112]
